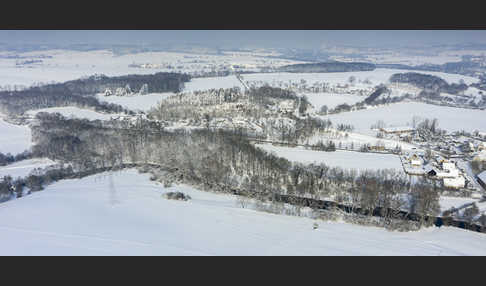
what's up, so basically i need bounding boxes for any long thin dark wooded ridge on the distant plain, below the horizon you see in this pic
[278,62,376,73]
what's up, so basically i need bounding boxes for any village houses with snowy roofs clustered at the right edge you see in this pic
[379,123,486,196]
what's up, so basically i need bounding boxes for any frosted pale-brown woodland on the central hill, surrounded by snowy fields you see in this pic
[149,86,330,143]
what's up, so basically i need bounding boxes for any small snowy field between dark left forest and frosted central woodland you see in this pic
[96,92,173,112]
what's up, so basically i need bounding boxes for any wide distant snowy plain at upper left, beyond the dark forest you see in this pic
[0,50,301,86]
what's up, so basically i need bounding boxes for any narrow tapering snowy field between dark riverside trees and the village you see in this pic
[256,144,403,170]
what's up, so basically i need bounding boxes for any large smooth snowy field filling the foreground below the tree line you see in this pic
[0,170,486,255]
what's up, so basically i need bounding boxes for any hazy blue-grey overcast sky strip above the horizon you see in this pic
[0,30,486,49]
